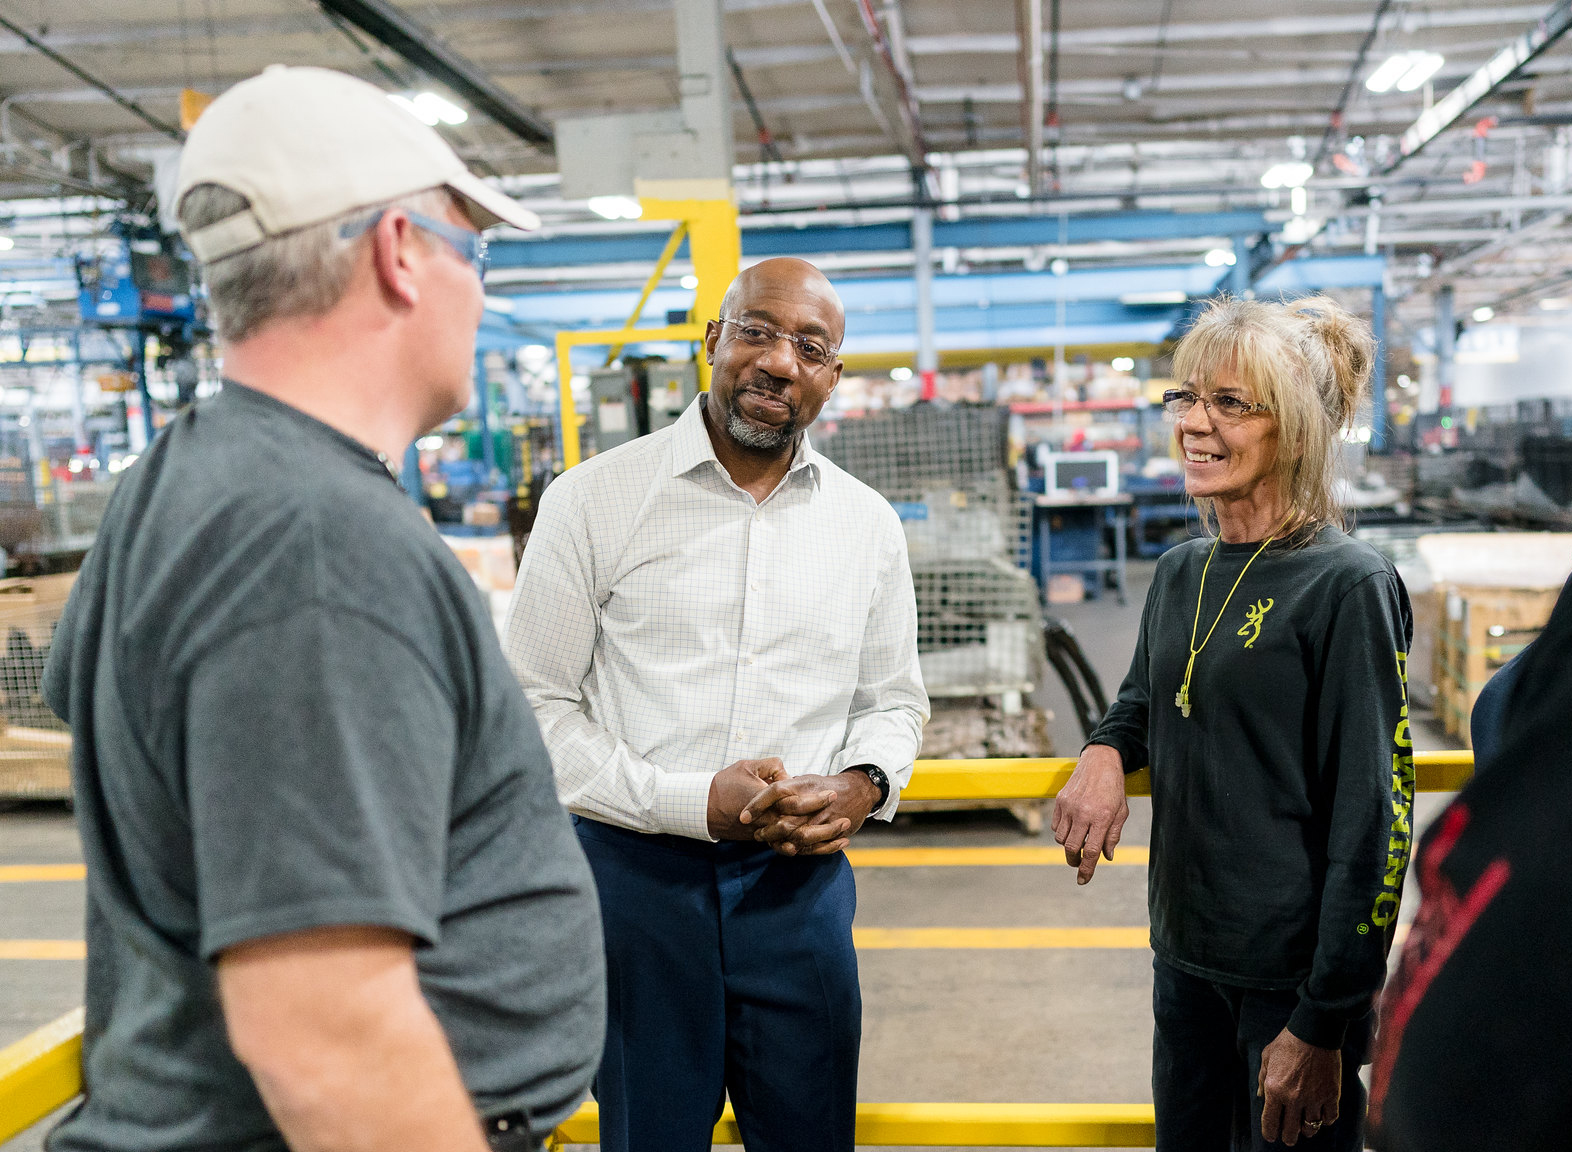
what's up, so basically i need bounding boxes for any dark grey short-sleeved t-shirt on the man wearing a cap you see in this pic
[44,383,605,1152]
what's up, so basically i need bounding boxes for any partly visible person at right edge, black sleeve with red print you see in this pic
[1369,572,1572,1152]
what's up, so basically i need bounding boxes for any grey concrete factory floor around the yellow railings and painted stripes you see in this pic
[0,563,1446,1152]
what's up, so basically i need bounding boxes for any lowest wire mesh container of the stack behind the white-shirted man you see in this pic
[912,559,1042,696]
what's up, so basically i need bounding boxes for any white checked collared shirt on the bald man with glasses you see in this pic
[503,394,927,839]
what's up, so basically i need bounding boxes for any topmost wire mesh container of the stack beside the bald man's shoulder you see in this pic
[816,404,1009,493]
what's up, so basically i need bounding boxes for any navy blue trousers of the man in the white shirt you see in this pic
[574,817,863,1152]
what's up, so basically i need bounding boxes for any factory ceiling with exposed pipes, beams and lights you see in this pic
[0,0,1572,333]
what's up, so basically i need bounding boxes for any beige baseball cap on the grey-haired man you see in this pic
[174,64,541,264]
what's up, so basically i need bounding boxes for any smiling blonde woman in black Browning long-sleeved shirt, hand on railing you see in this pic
[1053,297,1413,1152]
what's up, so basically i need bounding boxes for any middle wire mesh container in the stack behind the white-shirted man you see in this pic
[883,471,1031,569]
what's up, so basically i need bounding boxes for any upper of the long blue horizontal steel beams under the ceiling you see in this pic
[490,212,1270,269]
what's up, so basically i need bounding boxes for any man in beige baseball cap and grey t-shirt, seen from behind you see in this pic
[44,68,605,1152]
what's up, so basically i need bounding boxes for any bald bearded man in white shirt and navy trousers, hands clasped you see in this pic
[505,259,927,1152]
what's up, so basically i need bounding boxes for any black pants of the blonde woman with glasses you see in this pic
[1152,959,1369,1152]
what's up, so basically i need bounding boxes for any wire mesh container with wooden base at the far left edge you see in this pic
[0,574,75,800]
